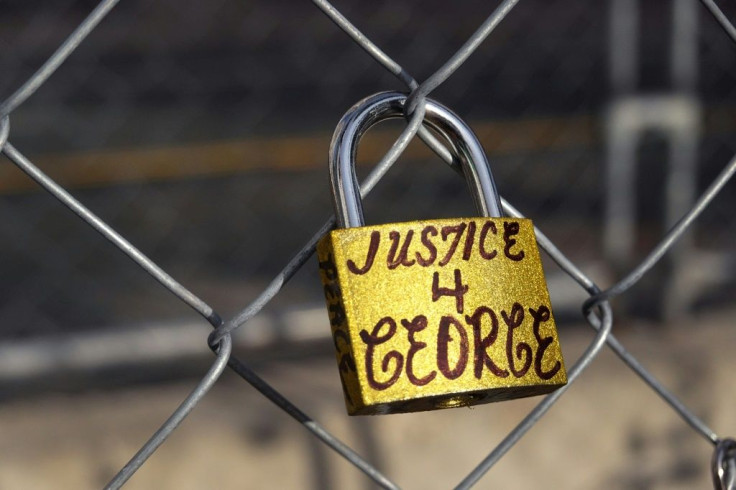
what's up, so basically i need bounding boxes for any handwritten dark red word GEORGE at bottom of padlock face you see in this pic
[360,303,561,390]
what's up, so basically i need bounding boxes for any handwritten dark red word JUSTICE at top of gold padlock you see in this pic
[347,221,524,275]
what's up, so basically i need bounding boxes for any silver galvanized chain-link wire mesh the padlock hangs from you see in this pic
[0,0,736,488]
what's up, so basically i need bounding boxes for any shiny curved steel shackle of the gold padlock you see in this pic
[329,92,501,228]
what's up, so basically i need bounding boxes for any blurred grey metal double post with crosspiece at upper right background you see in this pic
[604,0,702,318]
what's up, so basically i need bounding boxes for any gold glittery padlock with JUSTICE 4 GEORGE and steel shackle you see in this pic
[317,92,567,415]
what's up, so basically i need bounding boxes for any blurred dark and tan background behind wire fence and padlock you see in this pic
[0,0,736,489]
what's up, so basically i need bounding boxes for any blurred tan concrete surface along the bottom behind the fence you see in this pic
[0,310,736,490]
